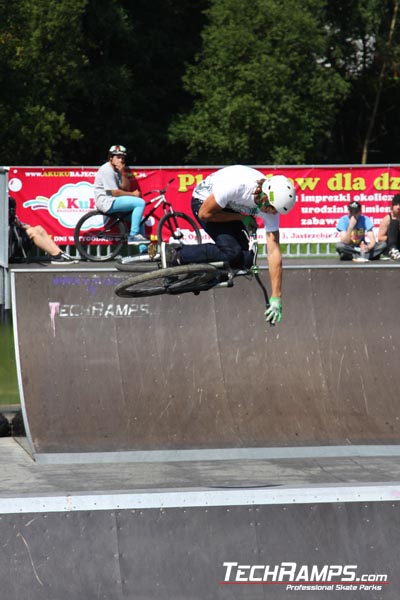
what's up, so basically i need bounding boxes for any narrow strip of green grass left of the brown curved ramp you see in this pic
[0,320,19,405]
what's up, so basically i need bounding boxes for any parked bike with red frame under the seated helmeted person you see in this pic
[74,179,201,262]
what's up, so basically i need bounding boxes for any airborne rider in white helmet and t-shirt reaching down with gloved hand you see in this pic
[161,165,296,324]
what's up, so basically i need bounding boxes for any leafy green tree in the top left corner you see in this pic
[0,0,86,164]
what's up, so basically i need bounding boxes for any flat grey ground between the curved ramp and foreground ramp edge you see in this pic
[0,438,400,498]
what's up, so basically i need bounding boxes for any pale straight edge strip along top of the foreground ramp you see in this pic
[0,483,400,514]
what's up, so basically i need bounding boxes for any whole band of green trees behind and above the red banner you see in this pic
[0,0,400,165]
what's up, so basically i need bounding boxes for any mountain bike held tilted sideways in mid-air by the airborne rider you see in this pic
[114,226,269,308]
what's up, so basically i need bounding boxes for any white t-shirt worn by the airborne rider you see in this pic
[193,165,279,231]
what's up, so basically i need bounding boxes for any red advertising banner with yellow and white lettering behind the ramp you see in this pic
[9,165,400,245]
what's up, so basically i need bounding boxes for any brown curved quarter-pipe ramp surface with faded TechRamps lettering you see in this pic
[8,261,400,458]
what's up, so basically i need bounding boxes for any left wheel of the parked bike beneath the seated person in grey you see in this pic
[74,210,127,262]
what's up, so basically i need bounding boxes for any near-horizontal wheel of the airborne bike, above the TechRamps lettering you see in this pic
[114,264,219,298]
